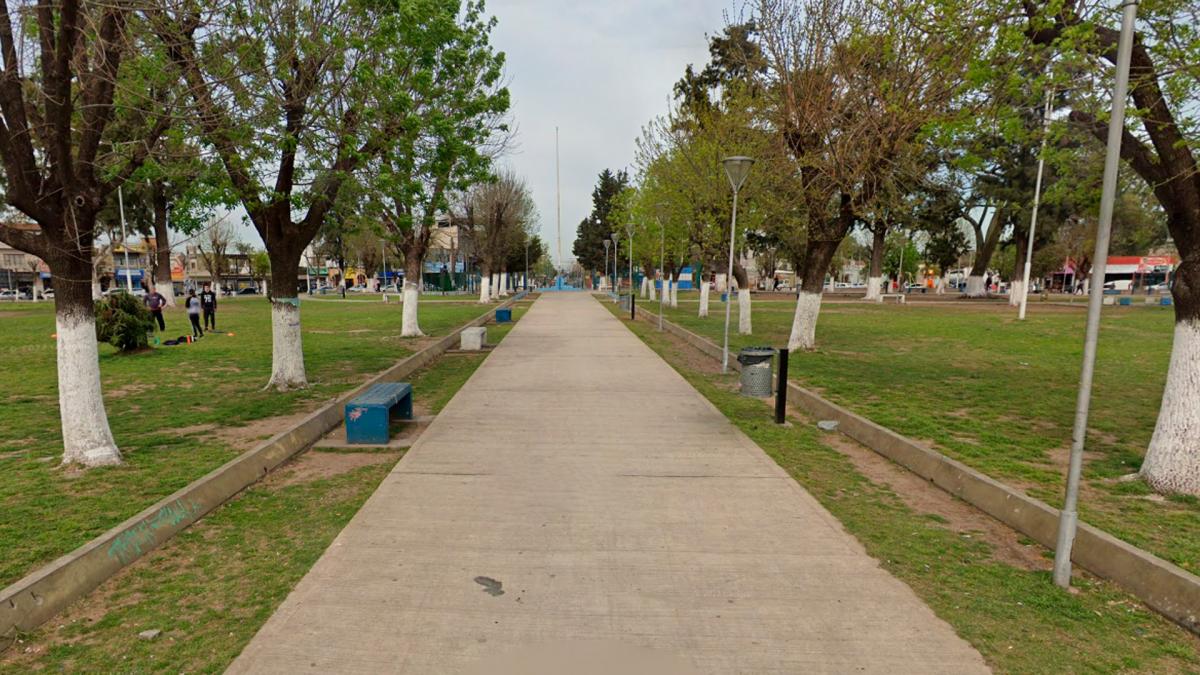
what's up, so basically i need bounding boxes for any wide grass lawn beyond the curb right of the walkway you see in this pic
[650,293,1200,572]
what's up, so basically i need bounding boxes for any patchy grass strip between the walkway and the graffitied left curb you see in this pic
[0,309,523,673]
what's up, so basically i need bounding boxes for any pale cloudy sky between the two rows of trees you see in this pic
[487,0,733,267]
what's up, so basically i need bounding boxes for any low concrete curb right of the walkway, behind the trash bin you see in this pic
[637,302,1200,633]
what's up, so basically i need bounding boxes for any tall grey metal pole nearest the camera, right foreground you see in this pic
[1054,0,1138,589]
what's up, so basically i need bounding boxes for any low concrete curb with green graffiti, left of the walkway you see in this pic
[0,292,524,635]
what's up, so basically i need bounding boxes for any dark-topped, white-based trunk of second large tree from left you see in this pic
[266,245,308,392]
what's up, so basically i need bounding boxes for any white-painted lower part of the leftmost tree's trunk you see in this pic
[54,313,121,467]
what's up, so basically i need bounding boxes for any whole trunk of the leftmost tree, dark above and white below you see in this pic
[46,252,121,467]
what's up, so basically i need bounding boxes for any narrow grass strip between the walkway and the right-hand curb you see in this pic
[608,305,1200,673]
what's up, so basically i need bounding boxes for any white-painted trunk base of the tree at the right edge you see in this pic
[1141,321,1200,496]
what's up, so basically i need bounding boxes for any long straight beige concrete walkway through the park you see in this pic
[230,293,986,674]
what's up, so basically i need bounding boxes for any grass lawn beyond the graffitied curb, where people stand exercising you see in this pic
[0,291,511,586]
